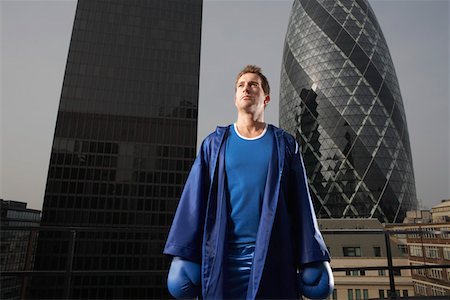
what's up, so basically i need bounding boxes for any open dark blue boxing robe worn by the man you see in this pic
[164,125,330,299]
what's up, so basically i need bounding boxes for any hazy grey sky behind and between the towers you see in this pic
[0,0,450,209]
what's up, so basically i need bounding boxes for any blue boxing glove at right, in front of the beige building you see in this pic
[298,261,334,299]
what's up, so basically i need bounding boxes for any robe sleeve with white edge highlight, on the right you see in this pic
[290,140,330,267]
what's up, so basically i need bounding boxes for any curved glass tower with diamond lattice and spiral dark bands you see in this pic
[280,0,417,222]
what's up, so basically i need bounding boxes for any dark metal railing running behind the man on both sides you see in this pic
[0,226,450,299]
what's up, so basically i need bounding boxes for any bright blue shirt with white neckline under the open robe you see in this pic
[225,124,274,243]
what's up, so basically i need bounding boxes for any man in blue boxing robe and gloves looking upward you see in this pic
[164,65,334,299]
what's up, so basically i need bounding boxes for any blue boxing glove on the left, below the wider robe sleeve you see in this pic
[167,257,201,299]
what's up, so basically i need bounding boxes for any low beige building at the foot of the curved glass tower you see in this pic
[318,219,414,300]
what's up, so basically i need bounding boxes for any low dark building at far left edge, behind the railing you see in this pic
[0,199,41,300]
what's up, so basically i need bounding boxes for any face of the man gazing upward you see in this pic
[234,73,270,113]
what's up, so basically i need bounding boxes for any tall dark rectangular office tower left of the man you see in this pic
[30,0,202,299]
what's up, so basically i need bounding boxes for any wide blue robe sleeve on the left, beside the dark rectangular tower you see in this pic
[163,141,209,263]
